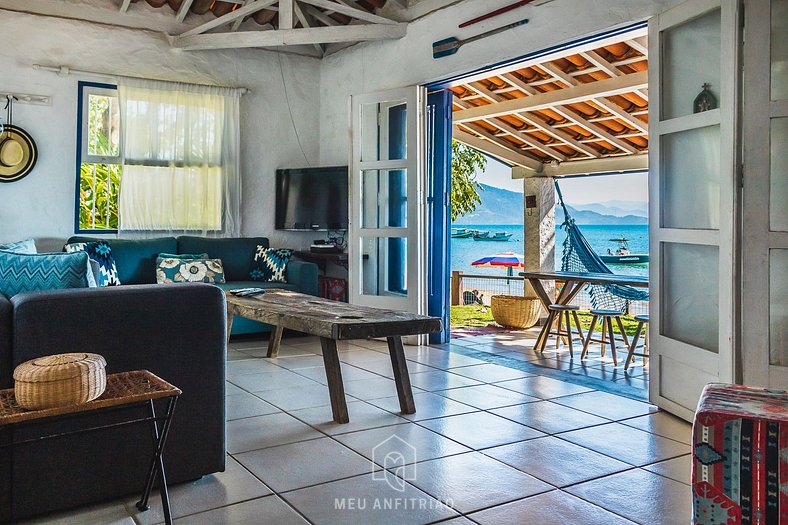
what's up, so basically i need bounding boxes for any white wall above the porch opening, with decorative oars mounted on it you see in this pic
[320,0,682,164]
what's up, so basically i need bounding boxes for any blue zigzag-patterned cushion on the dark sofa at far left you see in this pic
[0,251,92,297]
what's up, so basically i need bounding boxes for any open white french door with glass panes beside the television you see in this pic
[348,86,427,320]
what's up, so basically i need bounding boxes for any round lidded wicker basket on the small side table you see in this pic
[14,353,107,410]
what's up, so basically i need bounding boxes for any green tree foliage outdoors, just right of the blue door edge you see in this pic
[451,140,487,221]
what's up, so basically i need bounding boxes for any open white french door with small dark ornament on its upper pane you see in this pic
[649,0,741,419]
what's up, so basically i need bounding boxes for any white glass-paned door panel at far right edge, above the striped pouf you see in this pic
[742,0,788,389]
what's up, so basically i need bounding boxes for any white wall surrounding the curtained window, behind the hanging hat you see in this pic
[0,10,320,249]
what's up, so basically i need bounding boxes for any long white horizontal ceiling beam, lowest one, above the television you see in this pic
[171,22,407,51]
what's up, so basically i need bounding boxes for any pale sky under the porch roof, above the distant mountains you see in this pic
[476,157,648,204]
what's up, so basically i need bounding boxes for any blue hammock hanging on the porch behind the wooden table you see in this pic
[555,180,648,312]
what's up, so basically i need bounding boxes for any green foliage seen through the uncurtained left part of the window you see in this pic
[79,94,122,230]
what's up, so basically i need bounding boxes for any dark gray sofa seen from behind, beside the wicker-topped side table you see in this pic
[0,284,227,521]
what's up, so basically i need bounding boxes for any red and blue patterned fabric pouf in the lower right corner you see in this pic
[692,383,788,525]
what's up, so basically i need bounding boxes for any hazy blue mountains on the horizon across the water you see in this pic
[454,184,648,226]
